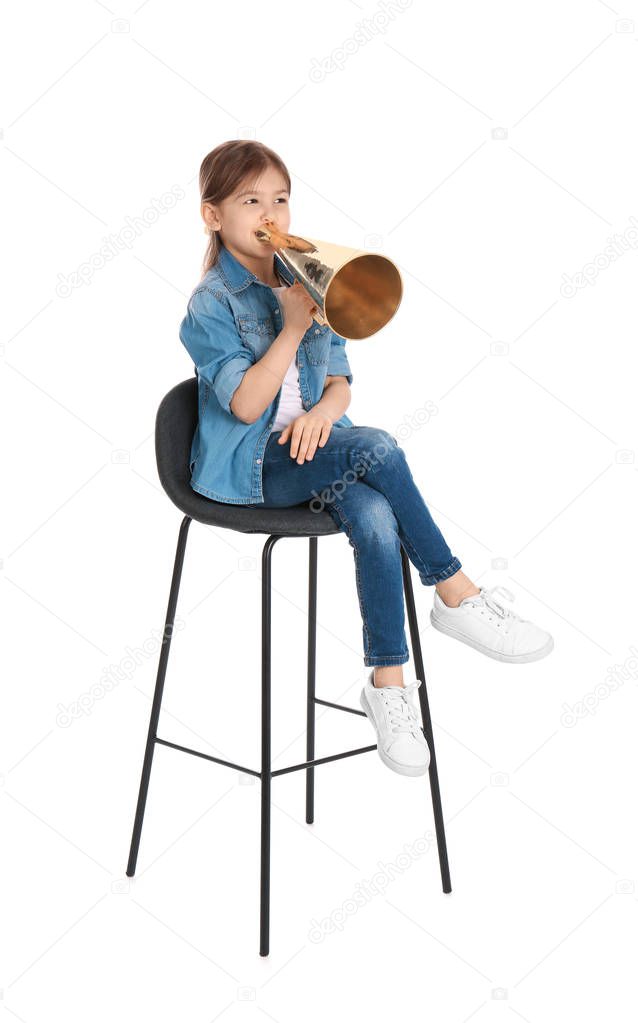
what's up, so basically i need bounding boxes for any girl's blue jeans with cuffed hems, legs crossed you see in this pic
[256,427,461,667]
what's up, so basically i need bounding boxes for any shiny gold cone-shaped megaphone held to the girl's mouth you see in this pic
[255,221,403,340]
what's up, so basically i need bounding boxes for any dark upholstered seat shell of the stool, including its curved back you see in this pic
[155,376,340,536]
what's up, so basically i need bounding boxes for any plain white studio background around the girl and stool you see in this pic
[0,0,638,1023]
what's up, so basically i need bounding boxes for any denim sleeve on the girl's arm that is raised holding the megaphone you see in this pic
[179,288,255,417]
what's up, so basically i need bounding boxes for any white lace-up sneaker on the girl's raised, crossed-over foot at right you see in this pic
[429,586,554,664]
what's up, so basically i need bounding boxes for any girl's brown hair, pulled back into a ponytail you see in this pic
[199,139,290,276]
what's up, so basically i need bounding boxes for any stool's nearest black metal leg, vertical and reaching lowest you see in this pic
[260,536,280,955]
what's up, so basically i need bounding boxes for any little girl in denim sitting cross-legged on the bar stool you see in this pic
[180,139,553,775]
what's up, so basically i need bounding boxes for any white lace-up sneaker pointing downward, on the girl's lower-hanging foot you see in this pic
[360,668,429,775]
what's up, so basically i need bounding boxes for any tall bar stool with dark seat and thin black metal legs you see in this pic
[126,379,452,955]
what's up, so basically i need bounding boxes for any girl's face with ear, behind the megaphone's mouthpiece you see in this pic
[202,167,290,266]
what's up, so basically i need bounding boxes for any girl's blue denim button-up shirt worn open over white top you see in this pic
[179,246,353,504]
